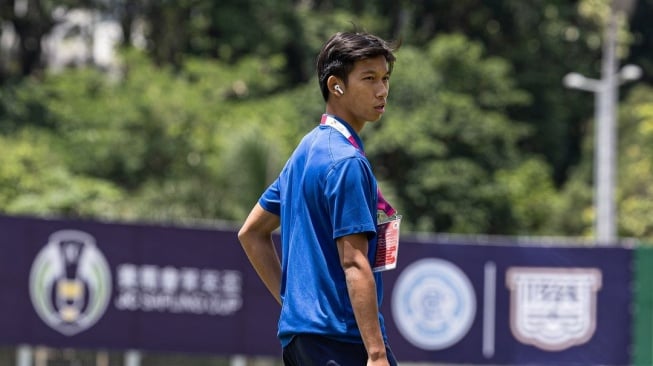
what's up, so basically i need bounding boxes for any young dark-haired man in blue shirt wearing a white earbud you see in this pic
[238,33,397,366]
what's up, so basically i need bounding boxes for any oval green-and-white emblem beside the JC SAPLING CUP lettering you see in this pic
[29,230,111,336]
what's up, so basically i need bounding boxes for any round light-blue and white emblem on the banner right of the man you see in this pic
[392,258,476,350]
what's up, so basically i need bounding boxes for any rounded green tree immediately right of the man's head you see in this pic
[368,35,528,233]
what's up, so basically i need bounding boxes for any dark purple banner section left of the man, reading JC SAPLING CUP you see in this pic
[0,217,279,355]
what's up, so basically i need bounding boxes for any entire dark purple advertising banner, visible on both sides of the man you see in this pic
[0,216,633,365]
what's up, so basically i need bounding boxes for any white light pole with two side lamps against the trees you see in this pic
[563,3,642,245]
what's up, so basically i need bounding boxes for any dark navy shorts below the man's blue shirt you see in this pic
[283,334,397,366]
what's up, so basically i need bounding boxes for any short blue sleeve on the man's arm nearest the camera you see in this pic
[325,158,376,239]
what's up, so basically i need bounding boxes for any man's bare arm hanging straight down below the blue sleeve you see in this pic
[337,234,388,365]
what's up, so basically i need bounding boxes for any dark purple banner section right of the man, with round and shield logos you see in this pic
[382,239,632,365]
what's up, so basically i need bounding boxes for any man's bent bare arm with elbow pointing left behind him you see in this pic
[238,203,281,304]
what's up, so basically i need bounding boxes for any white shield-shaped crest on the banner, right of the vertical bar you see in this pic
[507,267,601,351]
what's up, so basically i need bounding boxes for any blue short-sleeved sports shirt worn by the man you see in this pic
[259,116,386,347]
